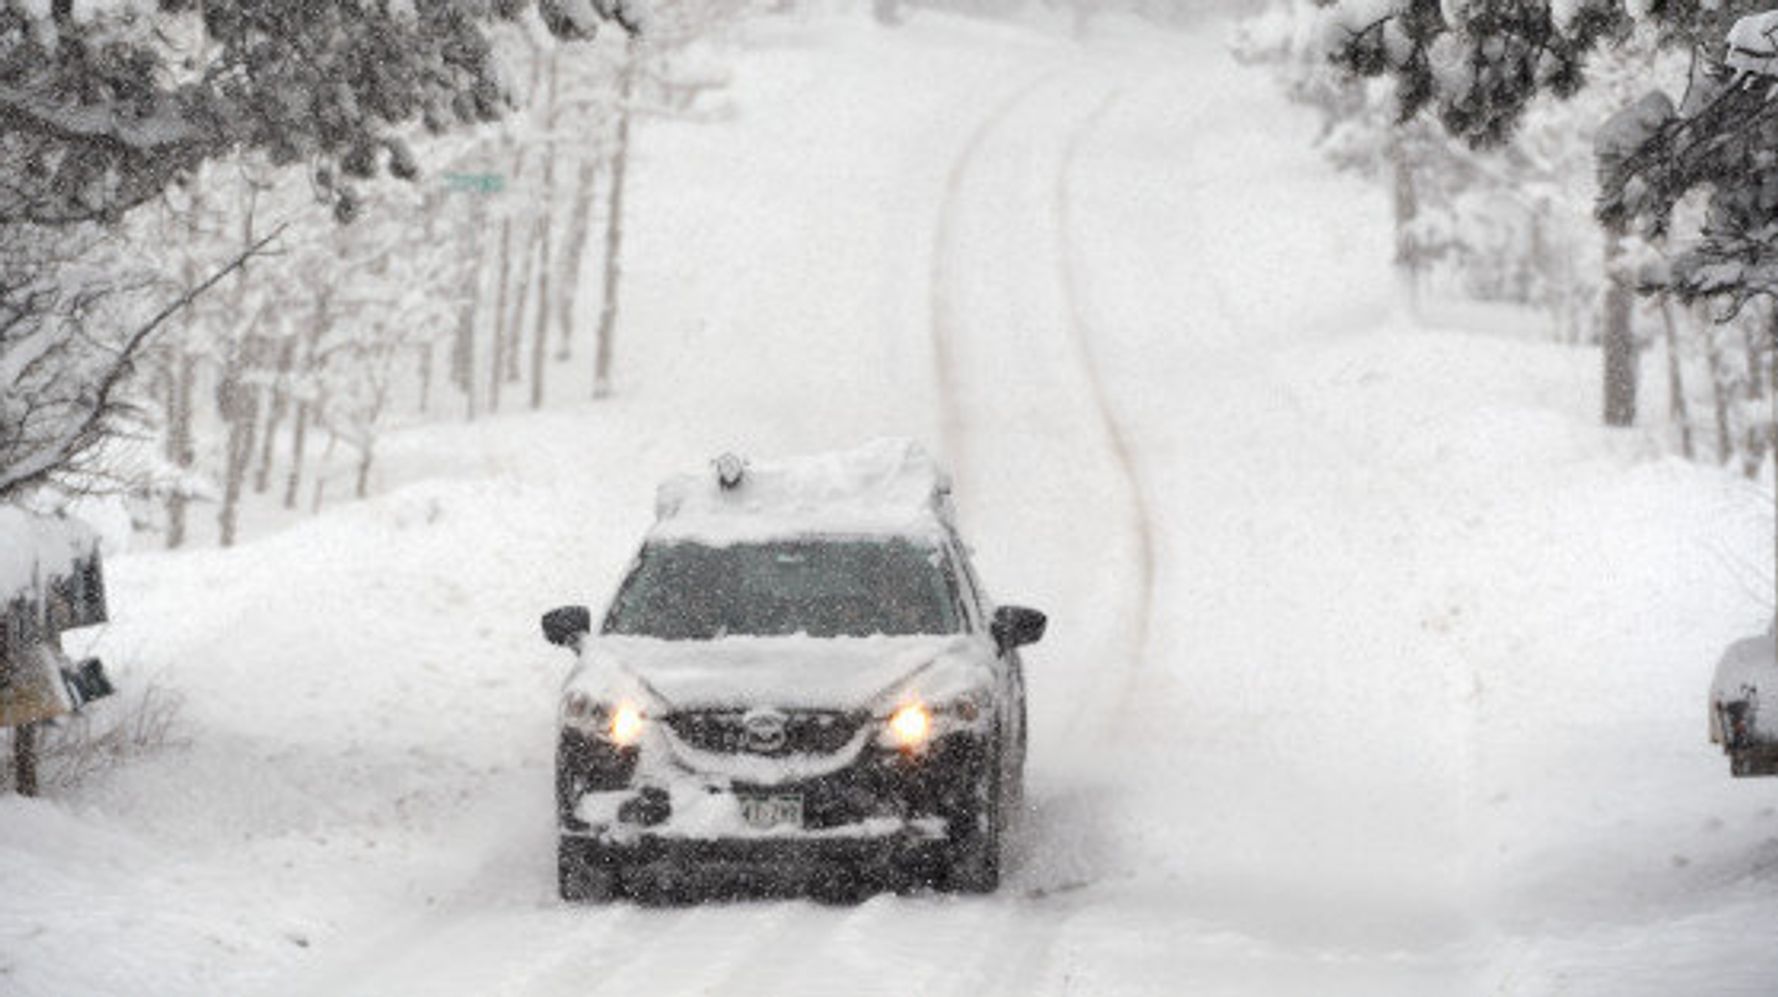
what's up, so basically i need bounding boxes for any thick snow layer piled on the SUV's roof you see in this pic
[649,439,955,546]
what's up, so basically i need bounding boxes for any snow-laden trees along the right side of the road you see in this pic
[1236,0,1778,478]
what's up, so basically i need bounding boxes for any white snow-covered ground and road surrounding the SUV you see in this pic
[0,11,1778,997]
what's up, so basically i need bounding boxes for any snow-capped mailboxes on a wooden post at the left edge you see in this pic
[0,506,112,793]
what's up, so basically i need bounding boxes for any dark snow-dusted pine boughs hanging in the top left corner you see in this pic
[0,0,644,224]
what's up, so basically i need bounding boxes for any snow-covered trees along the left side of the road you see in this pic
[0,0,738,546]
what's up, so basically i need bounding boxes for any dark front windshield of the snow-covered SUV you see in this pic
[605,538,960,640]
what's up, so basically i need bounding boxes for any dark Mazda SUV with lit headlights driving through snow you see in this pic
[542,441,1047,903]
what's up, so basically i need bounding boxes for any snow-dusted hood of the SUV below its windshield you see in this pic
[567,634,994,709]
